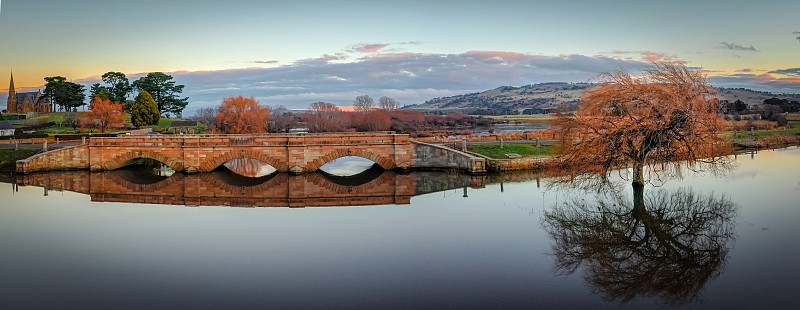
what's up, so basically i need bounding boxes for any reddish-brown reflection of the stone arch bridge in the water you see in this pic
[16,167,539,207]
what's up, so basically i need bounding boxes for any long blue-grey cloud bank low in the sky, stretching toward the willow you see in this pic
[138,50,648,115]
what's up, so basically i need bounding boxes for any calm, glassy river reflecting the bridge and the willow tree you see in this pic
[0,147,800,309]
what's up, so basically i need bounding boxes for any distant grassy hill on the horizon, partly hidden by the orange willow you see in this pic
[405,83,800,114]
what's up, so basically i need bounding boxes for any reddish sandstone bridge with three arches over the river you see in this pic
[16,132,486,174]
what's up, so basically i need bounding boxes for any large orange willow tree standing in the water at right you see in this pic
[553,63,727,186]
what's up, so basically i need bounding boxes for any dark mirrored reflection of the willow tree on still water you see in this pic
[543,185,738,305]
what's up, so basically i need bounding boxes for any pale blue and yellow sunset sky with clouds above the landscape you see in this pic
[0,0,800,114]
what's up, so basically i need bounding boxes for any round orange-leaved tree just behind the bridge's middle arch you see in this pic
[214,96,269,134]
